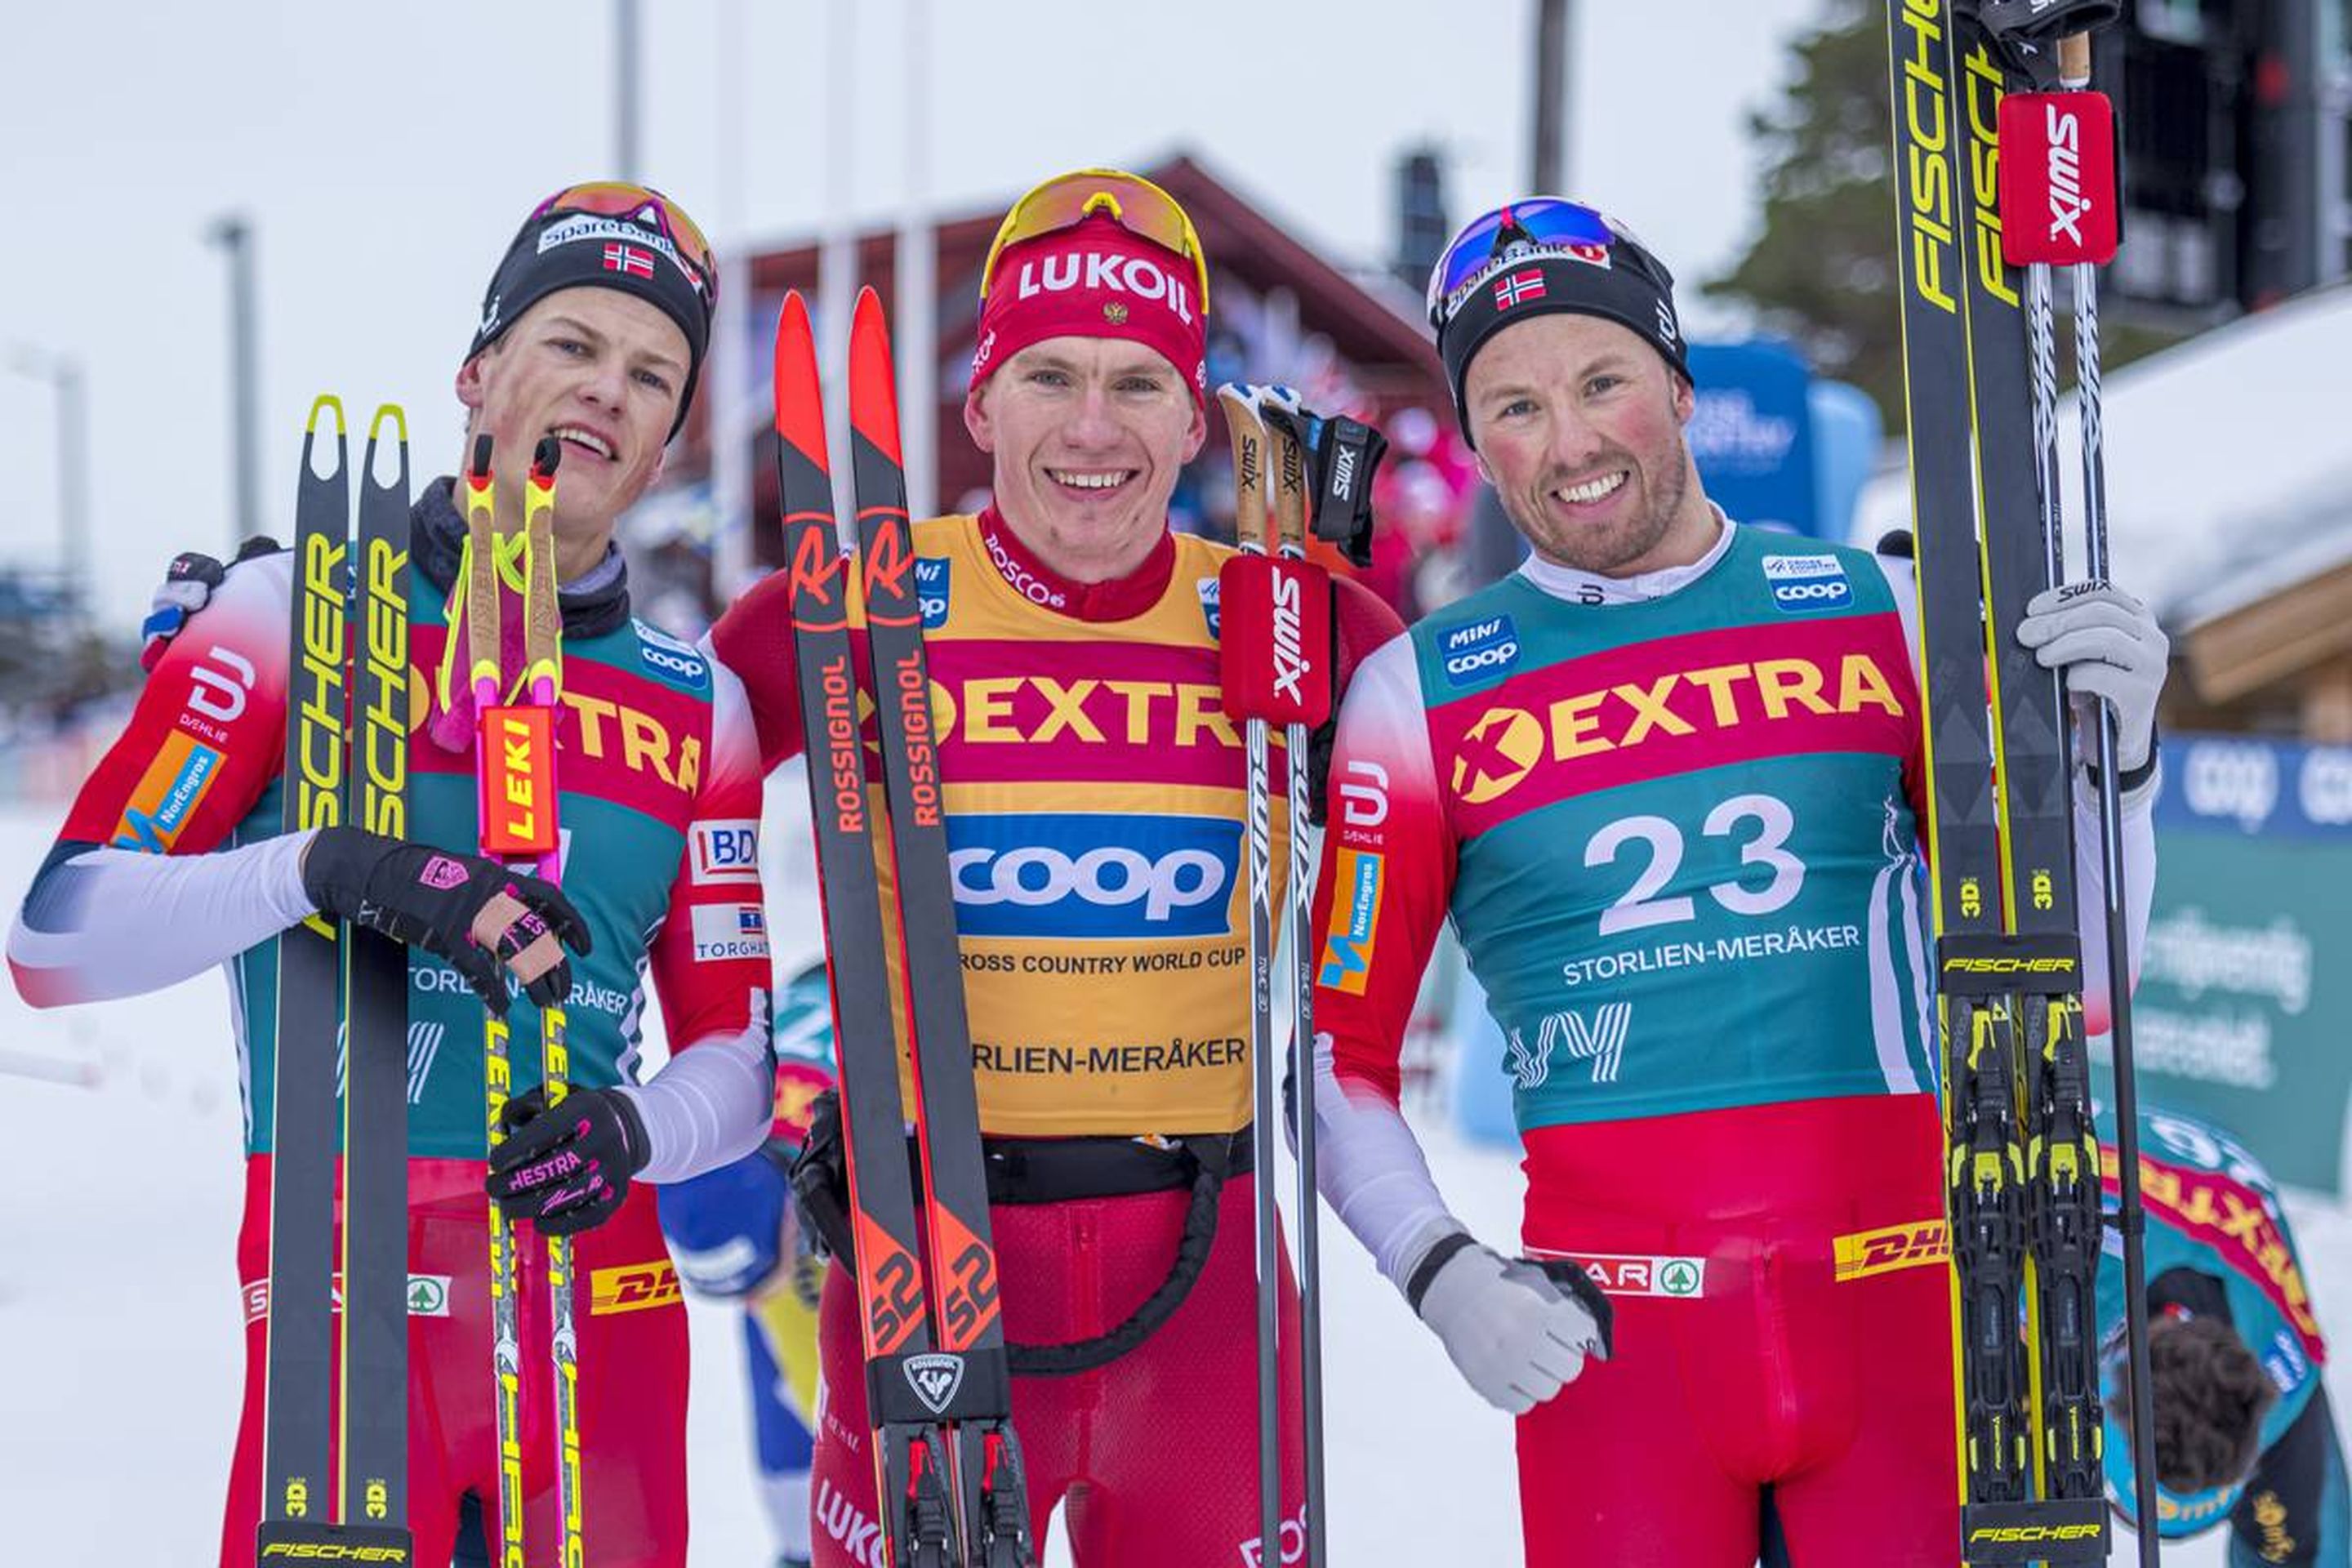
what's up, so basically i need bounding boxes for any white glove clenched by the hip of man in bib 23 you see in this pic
[1404,1229,1609,1415]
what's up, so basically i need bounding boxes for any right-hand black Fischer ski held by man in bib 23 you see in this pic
[1954,5,2105,1523]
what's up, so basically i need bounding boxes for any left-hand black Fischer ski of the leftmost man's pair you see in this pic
[259,397,350,1547]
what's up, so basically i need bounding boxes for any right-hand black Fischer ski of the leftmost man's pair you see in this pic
[339,404,409,1528]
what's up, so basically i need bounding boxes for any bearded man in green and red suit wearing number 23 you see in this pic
[1315,198,2164,1568]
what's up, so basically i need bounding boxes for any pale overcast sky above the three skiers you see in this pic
[0,0,1818,626]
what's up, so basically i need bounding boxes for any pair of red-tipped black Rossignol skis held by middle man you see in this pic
[774,292,1032,1568]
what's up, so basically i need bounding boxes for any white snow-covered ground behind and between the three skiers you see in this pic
[0,778,2352,1568]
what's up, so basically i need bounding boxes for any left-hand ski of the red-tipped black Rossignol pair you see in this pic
[774,289,962,1568]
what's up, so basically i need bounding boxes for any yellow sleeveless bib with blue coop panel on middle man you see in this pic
[892,517,1286,1138]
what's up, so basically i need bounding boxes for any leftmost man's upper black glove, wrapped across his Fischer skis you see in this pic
[301,827,590,1016]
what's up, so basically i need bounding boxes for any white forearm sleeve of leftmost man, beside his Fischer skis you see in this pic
[7,832,318,1006]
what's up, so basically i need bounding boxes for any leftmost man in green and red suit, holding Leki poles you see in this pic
[10,184,772,1568]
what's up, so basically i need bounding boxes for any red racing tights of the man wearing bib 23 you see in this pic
[1519,1095,1959,1568]
